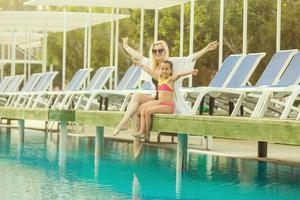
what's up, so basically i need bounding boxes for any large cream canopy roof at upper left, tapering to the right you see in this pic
[0,11,129,32]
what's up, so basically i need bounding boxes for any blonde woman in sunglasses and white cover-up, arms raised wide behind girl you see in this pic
[113,37,219,135]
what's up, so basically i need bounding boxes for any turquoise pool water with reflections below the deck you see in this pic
[0,129,300,200]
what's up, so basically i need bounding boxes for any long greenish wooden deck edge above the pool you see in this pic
[0,108,300,145]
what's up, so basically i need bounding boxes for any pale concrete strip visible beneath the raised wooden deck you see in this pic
[12,120,300,165]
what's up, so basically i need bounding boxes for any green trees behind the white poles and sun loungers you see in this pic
[0,0,300,85]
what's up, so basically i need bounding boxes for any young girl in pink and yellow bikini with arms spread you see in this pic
[132,61,198,138]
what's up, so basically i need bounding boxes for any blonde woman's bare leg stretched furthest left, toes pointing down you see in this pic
[113,94,154,135]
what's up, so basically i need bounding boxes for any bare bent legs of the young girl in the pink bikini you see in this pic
[145,105,173,137]
